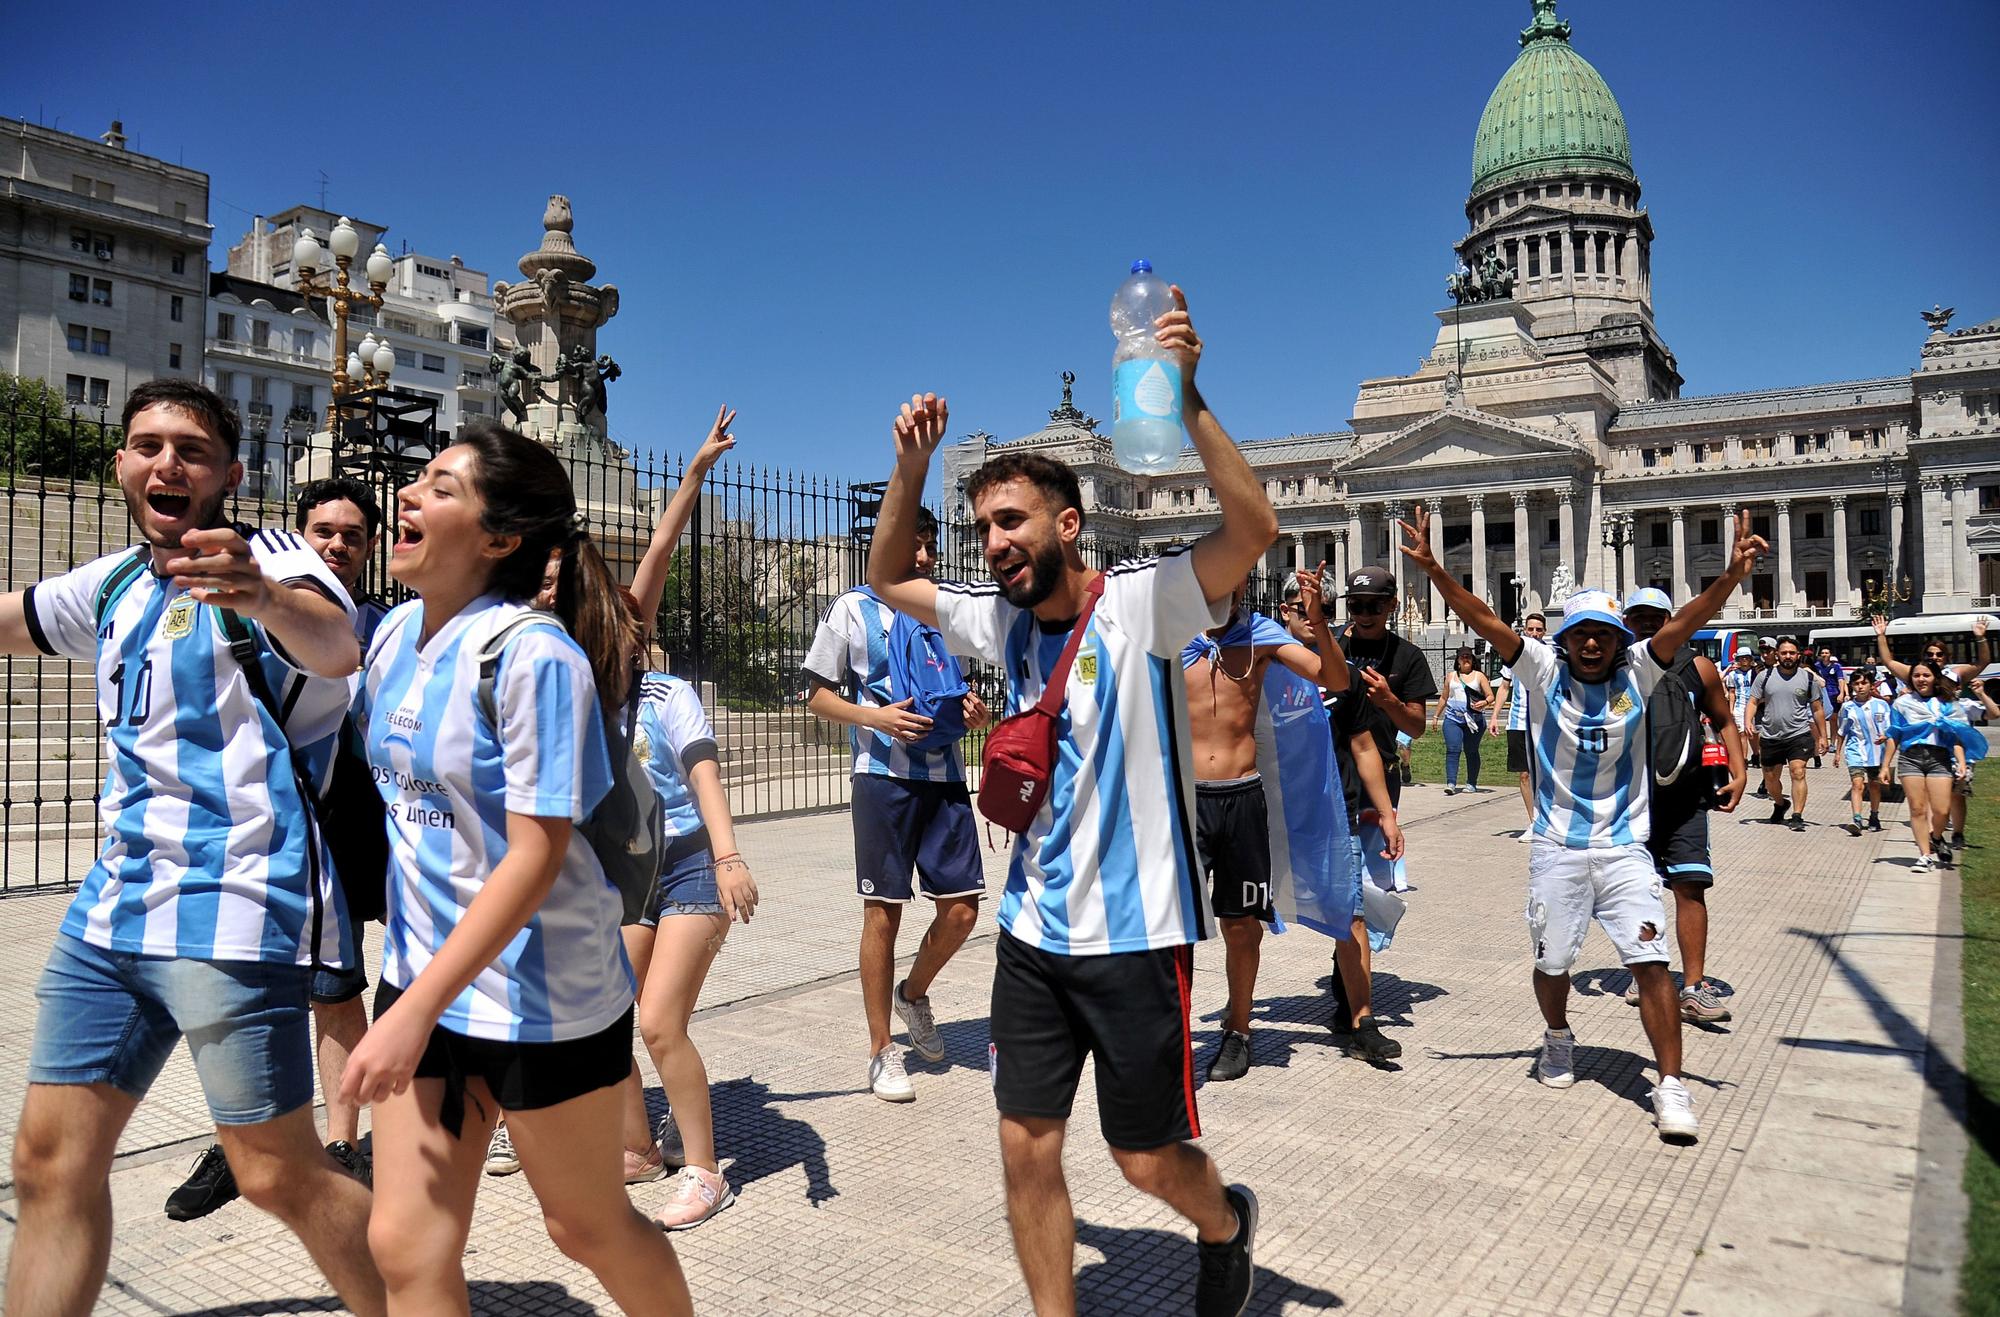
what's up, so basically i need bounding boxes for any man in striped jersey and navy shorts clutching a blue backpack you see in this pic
[804,508,986,1103]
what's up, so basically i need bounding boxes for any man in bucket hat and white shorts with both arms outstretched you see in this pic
[1398,506,1766,1139]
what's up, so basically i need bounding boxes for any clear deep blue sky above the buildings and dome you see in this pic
[0,0,2000,478]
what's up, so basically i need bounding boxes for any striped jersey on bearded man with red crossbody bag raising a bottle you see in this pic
[938,548,1230,955]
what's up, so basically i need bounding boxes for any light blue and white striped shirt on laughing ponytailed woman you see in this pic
[354,594,634,1043]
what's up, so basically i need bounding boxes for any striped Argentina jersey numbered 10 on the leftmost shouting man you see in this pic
[24,530,354,967]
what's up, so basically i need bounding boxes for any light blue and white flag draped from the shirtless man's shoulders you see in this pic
[1180,614,1354,939]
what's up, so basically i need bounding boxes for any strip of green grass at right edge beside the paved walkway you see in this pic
[1958,784,2000,1317]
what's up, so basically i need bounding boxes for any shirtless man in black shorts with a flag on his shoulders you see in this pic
[1182,572,1348,1081]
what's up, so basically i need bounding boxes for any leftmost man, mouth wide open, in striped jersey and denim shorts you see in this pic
[0,380,384,1315]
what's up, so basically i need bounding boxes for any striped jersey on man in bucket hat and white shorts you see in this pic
[1514,636,1664,851]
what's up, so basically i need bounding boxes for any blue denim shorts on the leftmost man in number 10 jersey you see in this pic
[28,933,312,1125]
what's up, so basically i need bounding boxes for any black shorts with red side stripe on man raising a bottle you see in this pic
[986,933,1202,1151]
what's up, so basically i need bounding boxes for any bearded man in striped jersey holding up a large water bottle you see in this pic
[868,288,1278,1317]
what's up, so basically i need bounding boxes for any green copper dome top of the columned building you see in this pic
[1472,0,1638,192]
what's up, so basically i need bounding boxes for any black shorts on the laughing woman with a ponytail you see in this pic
[376,983,632,1135]
